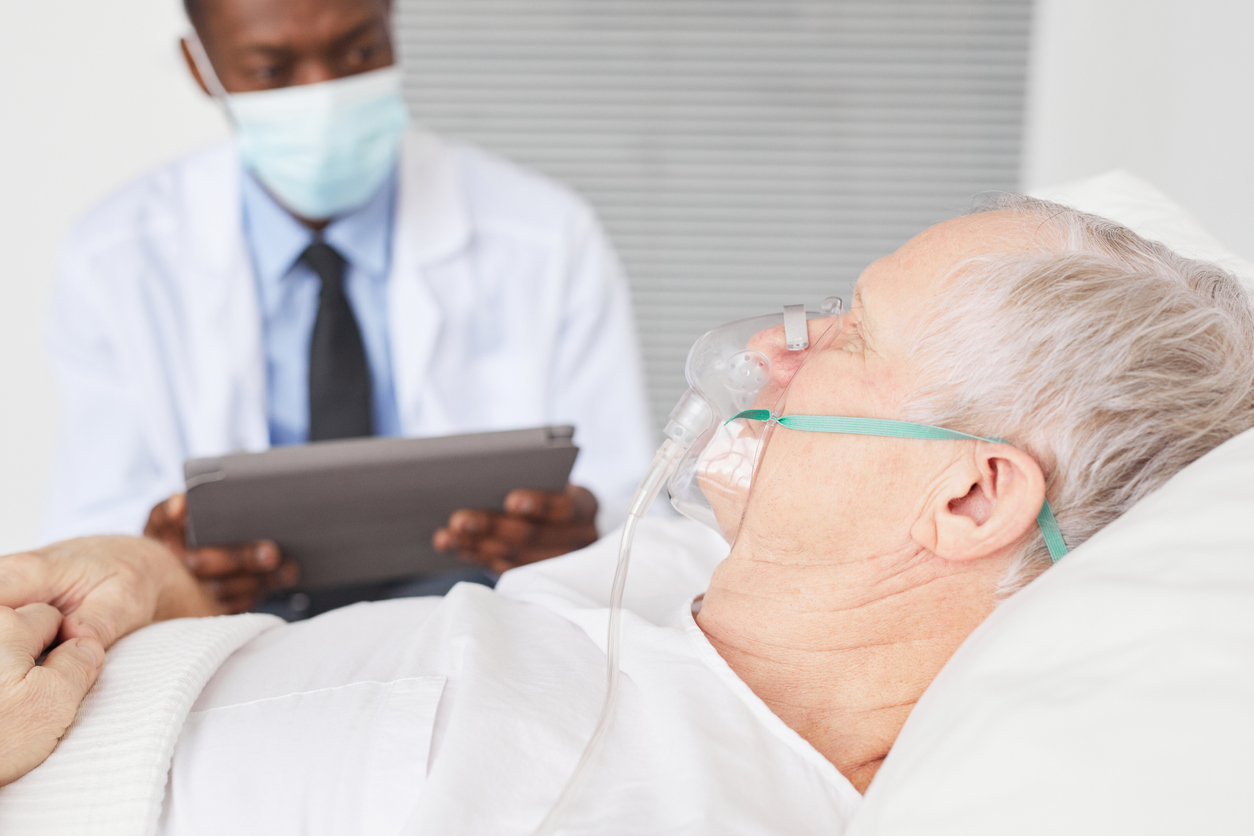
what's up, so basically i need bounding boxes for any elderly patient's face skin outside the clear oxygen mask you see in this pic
[716,213,1032,554]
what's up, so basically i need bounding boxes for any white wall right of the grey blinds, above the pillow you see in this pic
[1023,0,1254,258]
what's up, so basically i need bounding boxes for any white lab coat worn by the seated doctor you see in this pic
[44,132,652,540]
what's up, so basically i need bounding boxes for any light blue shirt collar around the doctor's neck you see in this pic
[241,169,396,287]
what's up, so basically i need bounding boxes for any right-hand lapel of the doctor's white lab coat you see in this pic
[387,132,470,435]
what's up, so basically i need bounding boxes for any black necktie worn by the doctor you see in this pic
[301,241,374,441]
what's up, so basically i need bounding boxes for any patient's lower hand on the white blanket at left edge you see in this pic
[0,604,104,786]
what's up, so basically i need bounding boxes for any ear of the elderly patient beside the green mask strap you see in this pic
[910,441,1045,560]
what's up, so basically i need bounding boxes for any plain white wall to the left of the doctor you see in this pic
[0,0,226,554]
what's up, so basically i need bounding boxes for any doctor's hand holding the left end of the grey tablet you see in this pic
[144,494,300,613]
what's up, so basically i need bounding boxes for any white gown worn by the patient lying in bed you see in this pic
[162,521,861,836]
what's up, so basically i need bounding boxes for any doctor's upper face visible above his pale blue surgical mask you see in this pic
[185,0,393,93]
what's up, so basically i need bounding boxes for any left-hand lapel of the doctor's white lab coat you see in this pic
[182,148,270,456]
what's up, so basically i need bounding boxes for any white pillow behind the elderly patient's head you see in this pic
[848,173,1254,836]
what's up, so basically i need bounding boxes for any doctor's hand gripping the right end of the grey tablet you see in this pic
[431,485,597,574]
